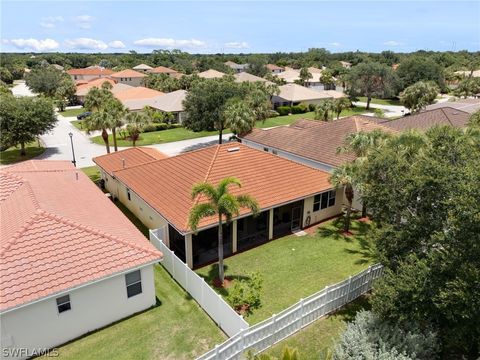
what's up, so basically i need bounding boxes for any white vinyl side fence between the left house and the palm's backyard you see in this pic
[150,228,248,336]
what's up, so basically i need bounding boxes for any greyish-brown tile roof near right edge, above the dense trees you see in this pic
[377,106,470,131]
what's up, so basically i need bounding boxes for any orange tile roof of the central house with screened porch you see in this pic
[115,143,332,233]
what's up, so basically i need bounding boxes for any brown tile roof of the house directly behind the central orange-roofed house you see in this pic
[244,115,395,166]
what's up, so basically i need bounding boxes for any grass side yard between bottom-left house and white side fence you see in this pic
[53,265,226,360]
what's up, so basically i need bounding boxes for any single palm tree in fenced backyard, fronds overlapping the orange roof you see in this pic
[188,177,259,284]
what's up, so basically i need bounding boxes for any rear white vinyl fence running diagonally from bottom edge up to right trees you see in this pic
[197,264,383,360]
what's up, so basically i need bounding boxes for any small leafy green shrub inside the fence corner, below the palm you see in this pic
[227,273,263,313]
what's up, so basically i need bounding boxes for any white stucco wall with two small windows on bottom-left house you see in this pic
[0,265,156,359]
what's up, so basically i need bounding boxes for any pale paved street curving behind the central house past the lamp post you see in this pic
[37,115,231,167]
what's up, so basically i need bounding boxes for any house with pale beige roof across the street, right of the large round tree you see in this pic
[272,84,345,107]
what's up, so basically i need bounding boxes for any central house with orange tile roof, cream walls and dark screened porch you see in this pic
[94,143,343,267]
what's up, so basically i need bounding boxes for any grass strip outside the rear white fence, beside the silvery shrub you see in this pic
[265,296,370,360]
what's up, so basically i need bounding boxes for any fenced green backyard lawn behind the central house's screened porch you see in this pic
[197,218,371,324]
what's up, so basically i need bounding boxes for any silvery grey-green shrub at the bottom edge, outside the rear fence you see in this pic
[334,311,439,360]
